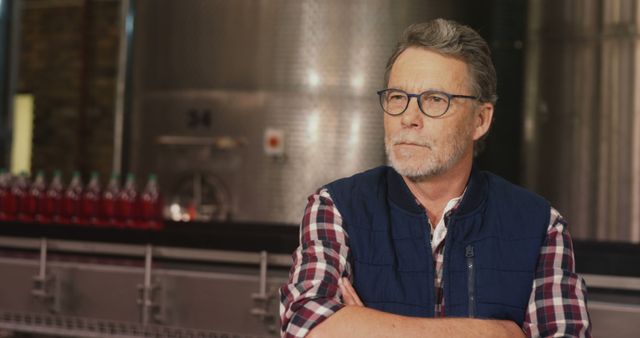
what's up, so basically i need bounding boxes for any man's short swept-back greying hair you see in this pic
[384,19,498,104]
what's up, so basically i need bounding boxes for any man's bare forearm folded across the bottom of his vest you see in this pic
[307,306,524,338]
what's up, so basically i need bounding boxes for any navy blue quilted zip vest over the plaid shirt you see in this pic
[327,167,550,325]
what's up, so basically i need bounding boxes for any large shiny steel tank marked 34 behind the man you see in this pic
[131,0,460,224]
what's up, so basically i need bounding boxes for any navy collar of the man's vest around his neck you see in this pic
[387,165,488,216]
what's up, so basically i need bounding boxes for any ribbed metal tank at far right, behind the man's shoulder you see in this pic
[524,0,640,243]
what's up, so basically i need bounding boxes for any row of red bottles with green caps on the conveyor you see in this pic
[0,169,163,229]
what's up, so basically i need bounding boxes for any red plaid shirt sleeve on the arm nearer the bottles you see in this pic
[280,189,350,337]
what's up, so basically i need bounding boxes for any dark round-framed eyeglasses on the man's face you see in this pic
[377,88,479,117]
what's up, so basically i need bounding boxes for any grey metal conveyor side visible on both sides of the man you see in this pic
[5,258,640,338]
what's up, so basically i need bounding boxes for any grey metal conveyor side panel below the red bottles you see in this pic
[0,252,287,336]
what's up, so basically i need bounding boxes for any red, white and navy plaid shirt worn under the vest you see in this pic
[280,189,591,337]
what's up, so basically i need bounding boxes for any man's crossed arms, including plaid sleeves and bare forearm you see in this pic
[280,190,591,337]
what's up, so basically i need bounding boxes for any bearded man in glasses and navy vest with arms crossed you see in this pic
[281,19,590,337]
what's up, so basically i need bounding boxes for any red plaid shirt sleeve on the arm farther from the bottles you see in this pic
[523,209,591,337]
